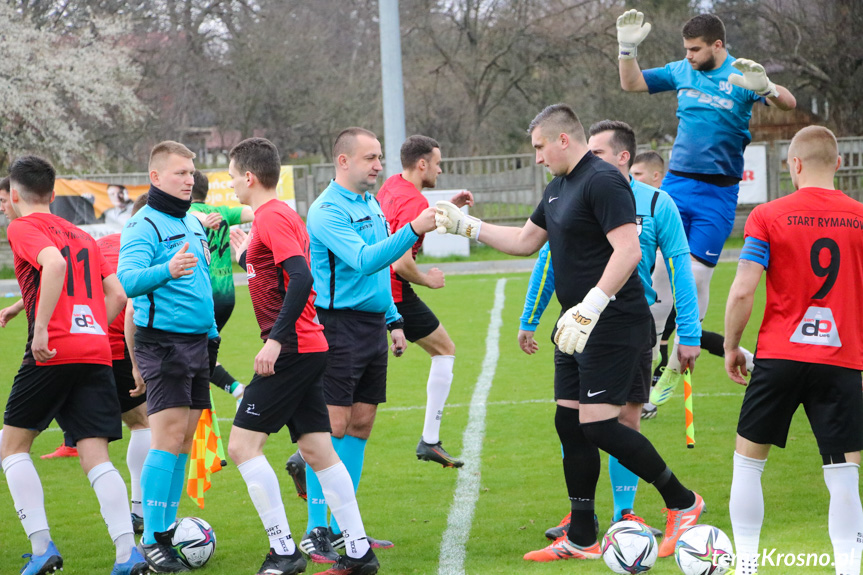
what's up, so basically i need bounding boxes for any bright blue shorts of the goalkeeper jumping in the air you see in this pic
[662,172,740,266]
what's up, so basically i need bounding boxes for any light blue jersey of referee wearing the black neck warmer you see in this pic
[117,206,219,339]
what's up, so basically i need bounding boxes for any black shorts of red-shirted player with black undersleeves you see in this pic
[234,351,331,443]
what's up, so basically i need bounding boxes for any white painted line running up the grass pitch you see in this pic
[438,278,506,575]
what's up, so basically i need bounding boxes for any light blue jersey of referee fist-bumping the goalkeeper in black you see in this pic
[306,180,418,323]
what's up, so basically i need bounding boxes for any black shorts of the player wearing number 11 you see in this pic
[3,363,123,443]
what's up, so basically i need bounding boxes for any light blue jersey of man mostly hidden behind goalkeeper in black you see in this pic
[521,178,701,345]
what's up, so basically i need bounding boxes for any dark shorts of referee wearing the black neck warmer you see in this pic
[135,326,210,415]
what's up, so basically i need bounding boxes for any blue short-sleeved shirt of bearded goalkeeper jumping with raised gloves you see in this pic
[642,54,766,178]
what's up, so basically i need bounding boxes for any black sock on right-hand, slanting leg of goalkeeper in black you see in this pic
[581,418,694,509]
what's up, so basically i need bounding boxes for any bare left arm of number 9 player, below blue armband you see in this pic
[724,260,764,385]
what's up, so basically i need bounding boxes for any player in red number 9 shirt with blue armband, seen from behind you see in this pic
[725,126,863,575]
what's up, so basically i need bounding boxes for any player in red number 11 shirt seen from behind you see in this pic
[0,156,147,575]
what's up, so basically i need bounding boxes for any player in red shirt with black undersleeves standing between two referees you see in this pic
[228,138,378,575]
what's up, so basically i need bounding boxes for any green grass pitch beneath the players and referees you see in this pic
[0,264,852,575]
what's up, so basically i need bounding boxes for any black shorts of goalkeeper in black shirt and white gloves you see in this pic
[554,318,651,405]
